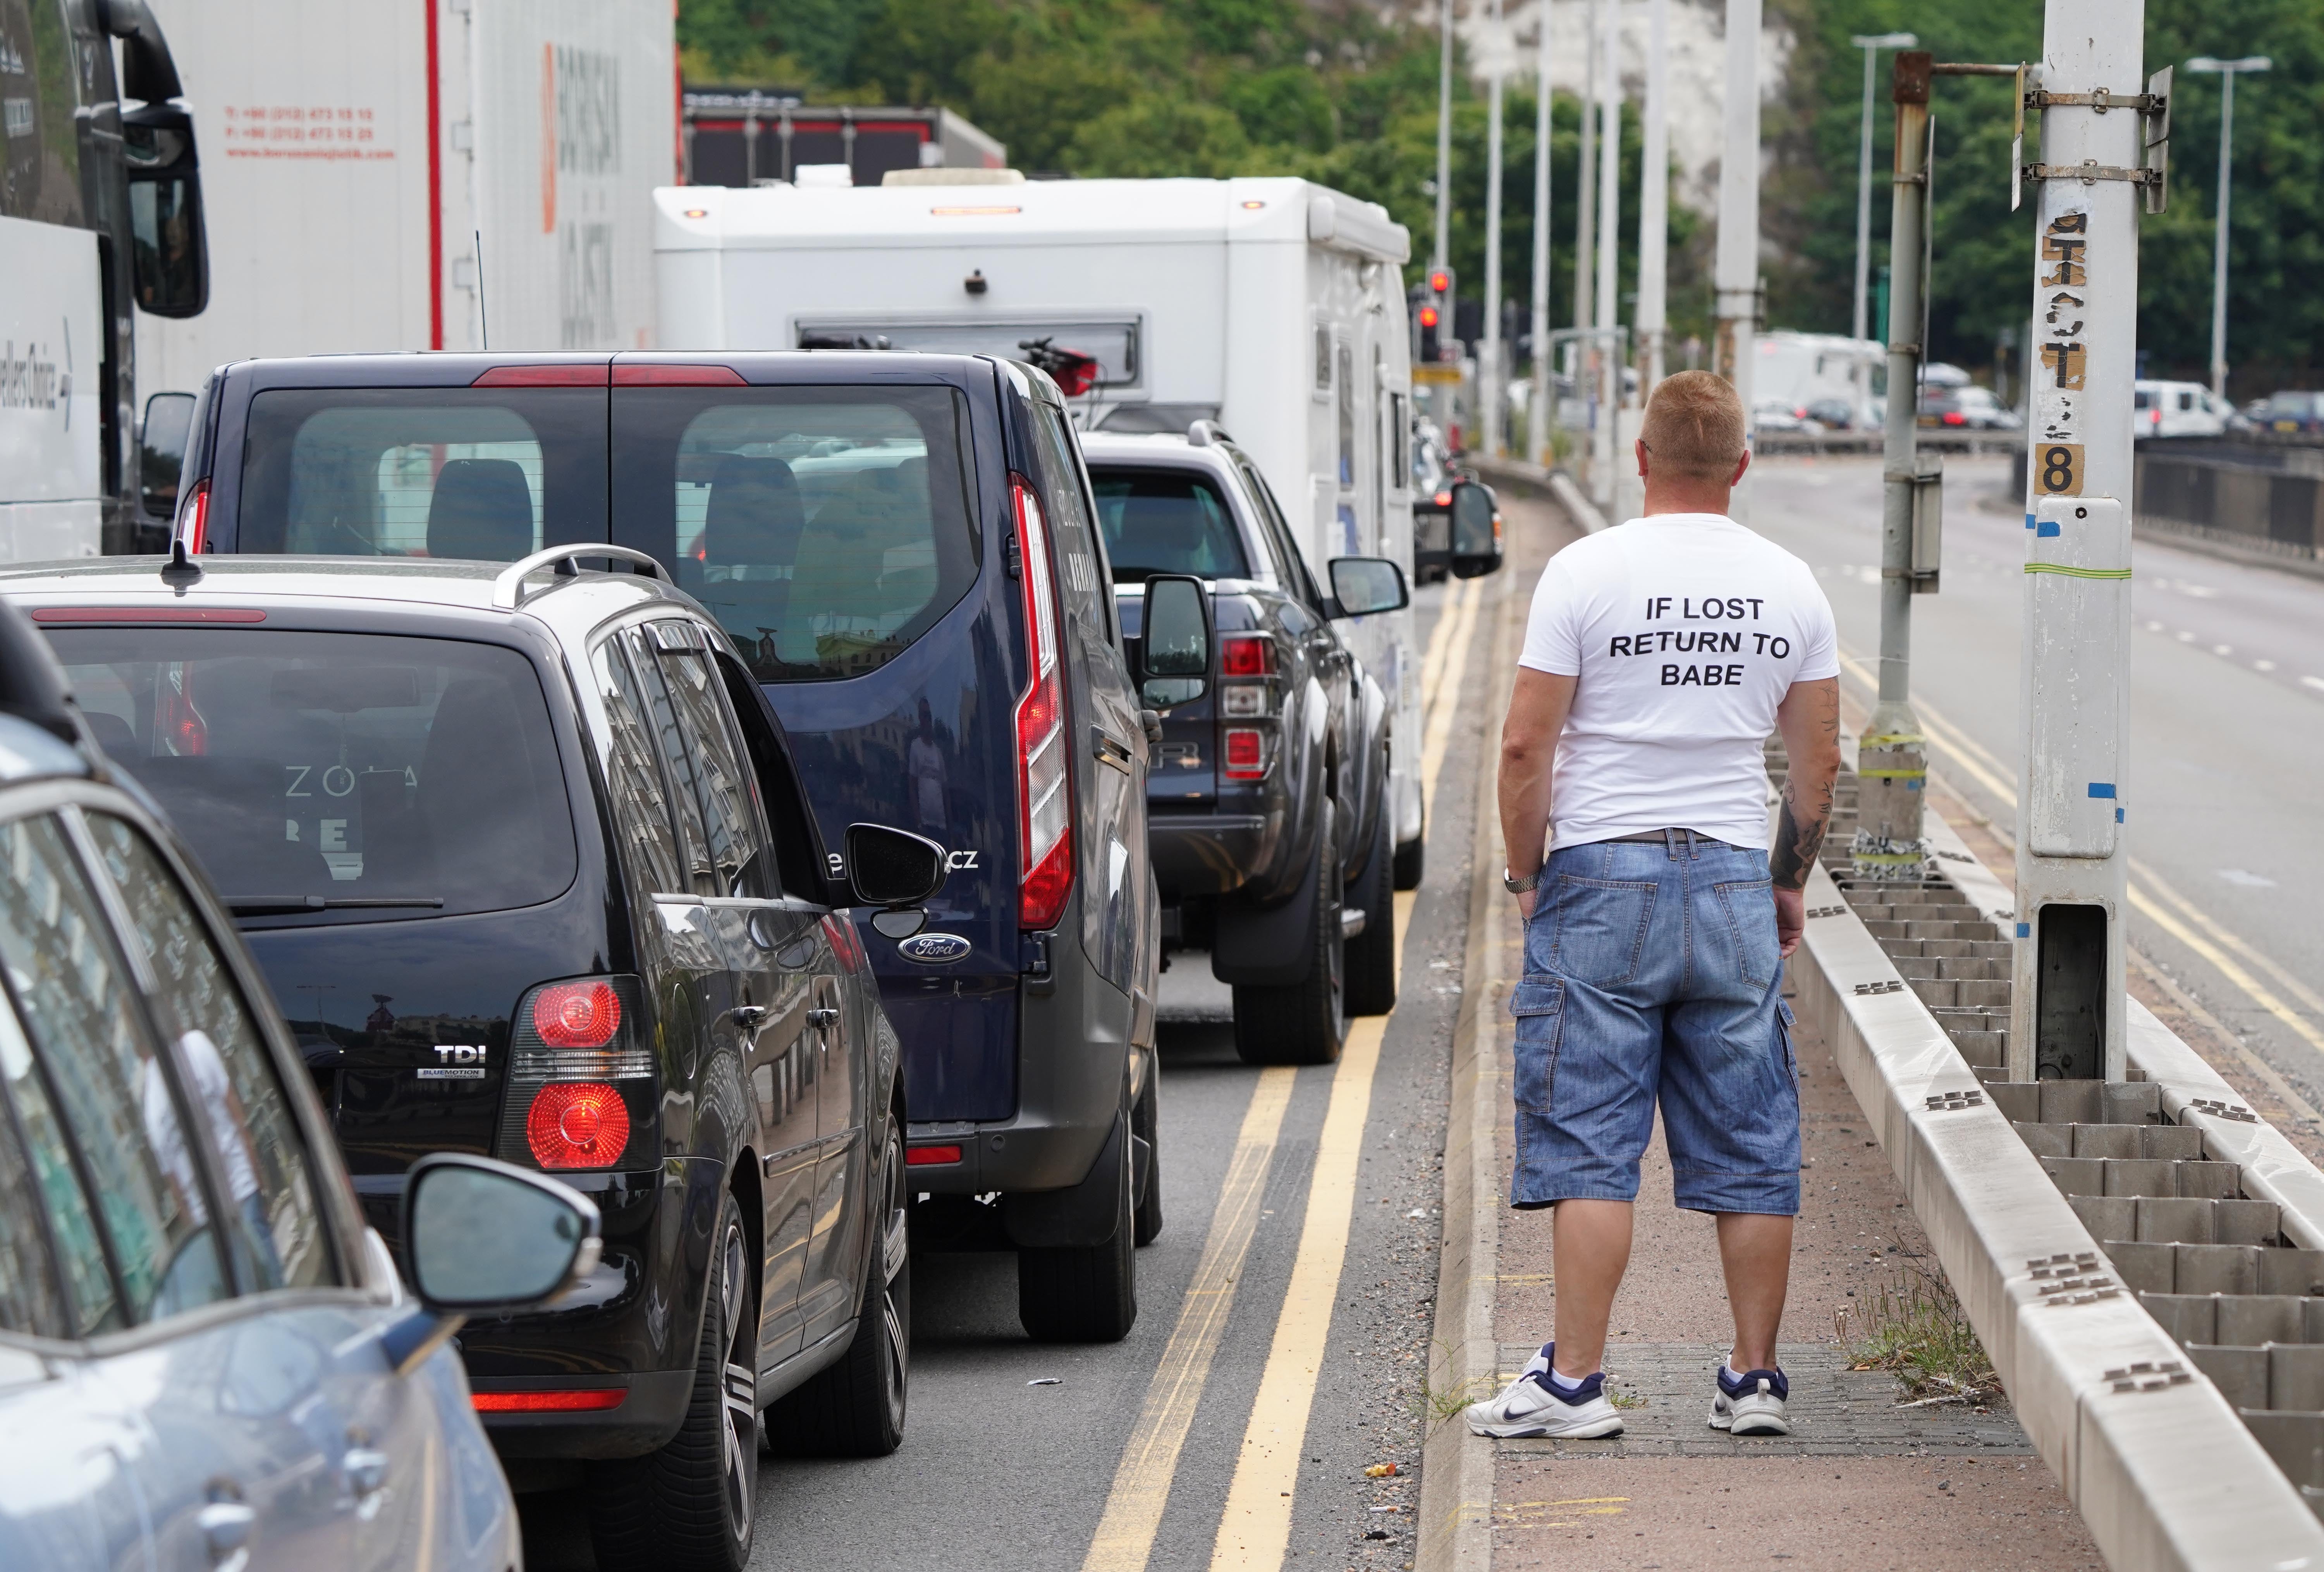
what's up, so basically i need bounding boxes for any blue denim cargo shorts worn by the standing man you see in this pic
[1508,830,1799,1216]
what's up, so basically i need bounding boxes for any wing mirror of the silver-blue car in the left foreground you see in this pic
[381,1151,604,1374]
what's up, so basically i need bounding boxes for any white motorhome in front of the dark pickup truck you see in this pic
[653,170,1422,879]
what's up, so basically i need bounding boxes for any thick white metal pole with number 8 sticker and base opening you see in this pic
[2008,0,2145,1081]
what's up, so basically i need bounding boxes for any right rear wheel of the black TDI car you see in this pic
[588,1195,758,1572]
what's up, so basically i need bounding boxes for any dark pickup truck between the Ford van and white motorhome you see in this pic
[1081,421,1408,1065]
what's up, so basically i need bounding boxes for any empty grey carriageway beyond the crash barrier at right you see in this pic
[1750,458,2324,1102]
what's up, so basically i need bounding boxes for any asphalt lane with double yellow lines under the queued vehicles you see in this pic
[525,546,1525,1572]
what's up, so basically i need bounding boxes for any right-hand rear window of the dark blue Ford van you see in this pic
[614,386,981,681]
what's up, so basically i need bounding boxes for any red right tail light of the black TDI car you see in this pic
[488,977,660,1170]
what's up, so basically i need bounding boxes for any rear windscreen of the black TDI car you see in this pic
[49,628,576,918]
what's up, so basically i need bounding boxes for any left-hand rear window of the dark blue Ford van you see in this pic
[235,388,607,563]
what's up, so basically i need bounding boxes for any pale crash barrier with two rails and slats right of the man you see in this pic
[1792,814,2324,1572]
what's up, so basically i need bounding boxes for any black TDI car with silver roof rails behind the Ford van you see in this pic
[0,549,944,1567]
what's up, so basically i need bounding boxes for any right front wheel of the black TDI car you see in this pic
[767,1118,911,1458]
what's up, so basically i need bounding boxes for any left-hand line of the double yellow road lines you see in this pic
[1081,1065,1299,1572]
